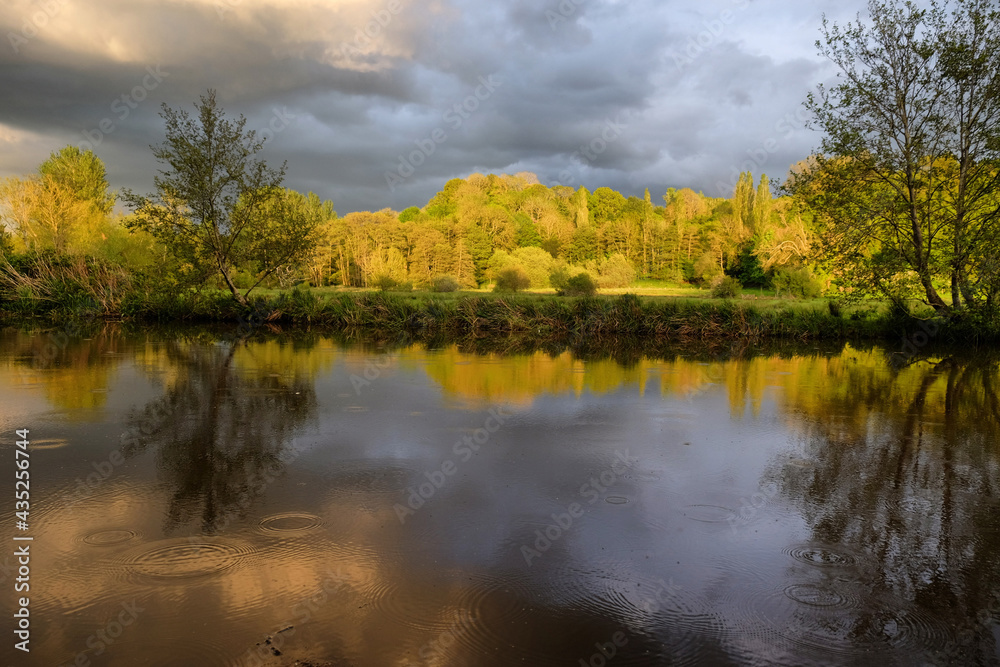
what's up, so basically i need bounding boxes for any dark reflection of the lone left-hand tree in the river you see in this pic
[124,341,316,533]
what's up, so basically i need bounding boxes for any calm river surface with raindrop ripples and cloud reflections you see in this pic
[0,329,1000,667]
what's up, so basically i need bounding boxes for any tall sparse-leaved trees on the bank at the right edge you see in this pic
[791,0,1000,314]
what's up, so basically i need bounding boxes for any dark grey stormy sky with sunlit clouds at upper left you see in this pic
[0,0,863,214]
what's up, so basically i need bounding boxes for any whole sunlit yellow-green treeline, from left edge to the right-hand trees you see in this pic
[0,146,813,290]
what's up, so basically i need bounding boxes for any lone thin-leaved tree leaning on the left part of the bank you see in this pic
[123,90,317,305]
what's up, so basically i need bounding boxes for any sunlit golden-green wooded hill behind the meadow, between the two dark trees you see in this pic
[300,173,811,287]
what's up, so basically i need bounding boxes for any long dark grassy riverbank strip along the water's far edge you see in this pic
[0,289,1000,347]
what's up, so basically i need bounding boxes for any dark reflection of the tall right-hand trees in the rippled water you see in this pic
[769,354,1000,665]
